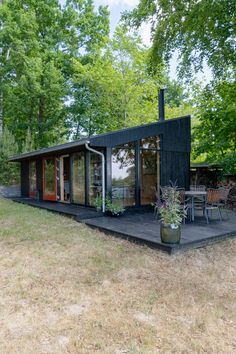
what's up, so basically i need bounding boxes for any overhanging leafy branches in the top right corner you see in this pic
[125,0,236,77]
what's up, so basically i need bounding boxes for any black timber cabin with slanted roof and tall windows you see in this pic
[10,116,191,207]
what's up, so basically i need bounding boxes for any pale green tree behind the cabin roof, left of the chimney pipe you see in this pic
[68,27,162,138]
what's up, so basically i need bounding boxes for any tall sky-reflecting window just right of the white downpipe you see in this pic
[112,144,135,206]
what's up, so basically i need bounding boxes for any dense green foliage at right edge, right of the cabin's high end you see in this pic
[193,81,236,174]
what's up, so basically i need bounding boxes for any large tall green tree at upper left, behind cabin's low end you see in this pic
[0,0,109,149]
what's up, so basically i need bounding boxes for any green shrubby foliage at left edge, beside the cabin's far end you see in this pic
[0,128,20,185]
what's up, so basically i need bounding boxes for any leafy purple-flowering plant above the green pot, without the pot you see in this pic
[159,186,186,228]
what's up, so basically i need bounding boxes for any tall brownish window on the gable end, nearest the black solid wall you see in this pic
[140,137,160,205]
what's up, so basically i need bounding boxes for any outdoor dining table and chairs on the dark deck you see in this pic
[154,185,230,224]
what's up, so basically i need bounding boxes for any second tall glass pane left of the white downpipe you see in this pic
[72,151,85,204]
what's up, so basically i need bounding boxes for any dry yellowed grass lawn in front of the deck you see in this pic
[0,199,236,354]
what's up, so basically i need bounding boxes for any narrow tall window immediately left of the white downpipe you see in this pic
[89,153,102,206]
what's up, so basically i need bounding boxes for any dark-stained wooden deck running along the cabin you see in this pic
[12,198,236,254]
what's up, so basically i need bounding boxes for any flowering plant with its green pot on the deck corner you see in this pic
[159,186,186,243]
